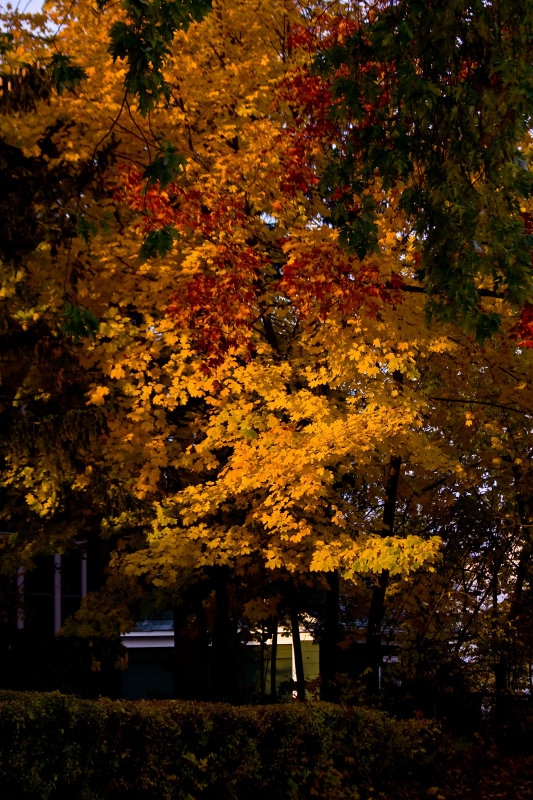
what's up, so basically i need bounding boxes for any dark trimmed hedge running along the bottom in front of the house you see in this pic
[0,692,444,800]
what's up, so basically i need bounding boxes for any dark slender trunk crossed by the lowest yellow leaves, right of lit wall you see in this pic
[366,456,401,697]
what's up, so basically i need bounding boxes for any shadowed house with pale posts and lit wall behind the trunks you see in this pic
[0,546,319,699]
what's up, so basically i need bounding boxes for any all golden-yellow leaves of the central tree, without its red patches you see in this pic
[10,0,527,600]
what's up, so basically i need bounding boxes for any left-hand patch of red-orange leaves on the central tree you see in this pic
[117,163,268,368]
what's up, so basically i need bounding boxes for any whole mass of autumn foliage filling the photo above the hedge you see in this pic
[0,0,533,698]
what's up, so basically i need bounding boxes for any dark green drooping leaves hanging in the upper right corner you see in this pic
[316,0,533,338]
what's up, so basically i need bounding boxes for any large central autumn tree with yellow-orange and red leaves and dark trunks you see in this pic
[1,0,530,708]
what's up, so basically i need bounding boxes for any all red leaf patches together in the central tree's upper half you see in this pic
[109,6,399,369]
